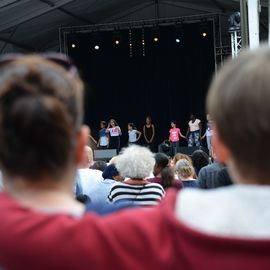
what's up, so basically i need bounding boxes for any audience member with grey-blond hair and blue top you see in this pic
[175,159,198,188]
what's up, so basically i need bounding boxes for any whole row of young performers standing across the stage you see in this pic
[92,114,212,155]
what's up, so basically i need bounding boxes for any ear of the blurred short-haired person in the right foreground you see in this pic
[213,127,231,164]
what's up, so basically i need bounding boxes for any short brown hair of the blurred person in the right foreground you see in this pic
[207,47,270,184]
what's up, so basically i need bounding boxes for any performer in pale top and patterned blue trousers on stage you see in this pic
[186,114,202,147]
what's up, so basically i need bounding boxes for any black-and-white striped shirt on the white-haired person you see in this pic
[108,183,165,206]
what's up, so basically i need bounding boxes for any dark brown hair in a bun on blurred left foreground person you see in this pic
[0,56,82,181]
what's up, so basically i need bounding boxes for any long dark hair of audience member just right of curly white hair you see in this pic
[154,153,175,188]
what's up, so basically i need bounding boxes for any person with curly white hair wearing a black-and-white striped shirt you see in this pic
[108,145,165,206]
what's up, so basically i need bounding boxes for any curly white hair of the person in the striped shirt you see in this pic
[116,145,155,180]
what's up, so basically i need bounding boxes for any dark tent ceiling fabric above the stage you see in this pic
[0,0,267,53]
